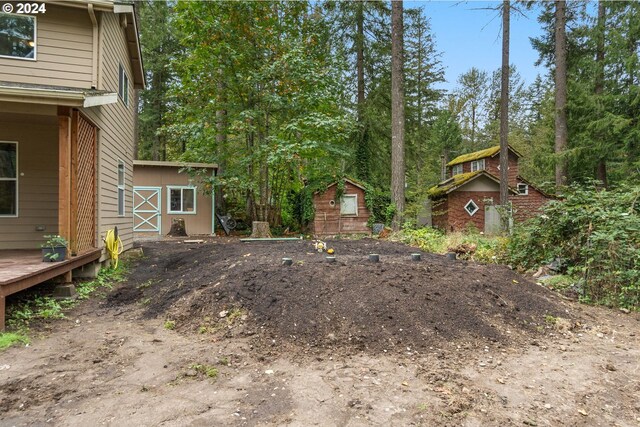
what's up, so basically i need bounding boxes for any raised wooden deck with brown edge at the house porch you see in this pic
[0,249,102,331]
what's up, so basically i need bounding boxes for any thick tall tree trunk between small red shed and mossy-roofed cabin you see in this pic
[391,0,405,231]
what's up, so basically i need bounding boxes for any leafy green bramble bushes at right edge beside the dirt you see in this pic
[509,184,640,309]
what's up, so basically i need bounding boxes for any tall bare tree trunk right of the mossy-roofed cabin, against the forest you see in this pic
[554,0,568,187]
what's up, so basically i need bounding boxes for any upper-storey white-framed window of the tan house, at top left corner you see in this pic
[0,14,36,59]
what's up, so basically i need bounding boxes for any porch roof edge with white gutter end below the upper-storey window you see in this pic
[0,81,118,108]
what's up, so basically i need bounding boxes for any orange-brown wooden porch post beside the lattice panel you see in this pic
[58,107,71,244]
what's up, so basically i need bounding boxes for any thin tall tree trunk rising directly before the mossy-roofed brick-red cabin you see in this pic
[500,0,511,211]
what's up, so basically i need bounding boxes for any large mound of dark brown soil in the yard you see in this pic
[109,239,567,353]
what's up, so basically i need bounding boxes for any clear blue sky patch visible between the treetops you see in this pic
[412,1,546,89]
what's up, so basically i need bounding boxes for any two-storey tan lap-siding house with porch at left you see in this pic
[0,0,144,329]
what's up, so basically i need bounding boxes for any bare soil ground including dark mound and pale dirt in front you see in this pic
[0,239,640,426]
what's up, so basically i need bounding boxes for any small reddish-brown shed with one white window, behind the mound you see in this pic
[311,179,371,236]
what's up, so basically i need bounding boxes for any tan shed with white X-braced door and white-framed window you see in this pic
[133,160,217,238]
